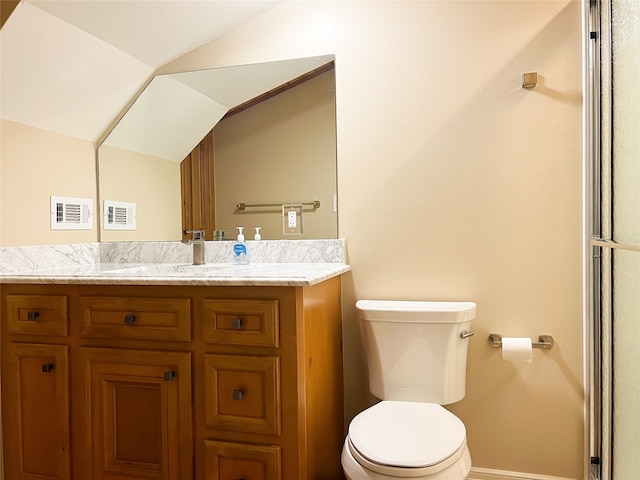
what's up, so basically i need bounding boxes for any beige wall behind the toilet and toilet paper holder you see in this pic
[167,1,584,479]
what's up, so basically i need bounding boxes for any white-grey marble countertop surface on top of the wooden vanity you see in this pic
[0,263,350,286]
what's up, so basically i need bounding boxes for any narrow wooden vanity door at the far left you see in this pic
[2,343,70,480]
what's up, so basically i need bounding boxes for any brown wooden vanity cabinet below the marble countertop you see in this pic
[1,277,344,480]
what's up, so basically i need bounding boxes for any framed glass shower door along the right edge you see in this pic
[587,0,640,480]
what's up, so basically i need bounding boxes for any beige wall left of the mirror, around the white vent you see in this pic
[0,120,98,247]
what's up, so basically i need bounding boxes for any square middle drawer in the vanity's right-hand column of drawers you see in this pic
[204,354,281,435]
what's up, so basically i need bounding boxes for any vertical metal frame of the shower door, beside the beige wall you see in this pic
[585,0,613,480]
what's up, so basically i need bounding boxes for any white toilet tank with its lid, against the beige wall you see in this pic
[356,300,476,405]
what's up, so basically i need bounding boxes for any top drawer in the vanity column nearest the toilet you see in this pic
[202,300,280,347]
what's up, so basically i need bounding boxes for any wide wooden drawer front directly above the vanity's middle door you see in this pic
[78,297,191,342]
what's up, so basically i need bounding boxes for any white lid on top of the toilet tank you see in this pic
[356,300,476,323]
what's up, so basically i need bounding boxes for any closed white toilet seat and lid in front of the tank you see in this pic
[348,401,467,477]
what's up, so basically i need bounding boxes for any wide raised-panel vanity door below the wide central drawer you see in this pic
[79,348,193,480]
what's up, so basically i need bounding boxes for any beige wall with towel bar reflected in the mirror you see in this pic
[214,71,338,240]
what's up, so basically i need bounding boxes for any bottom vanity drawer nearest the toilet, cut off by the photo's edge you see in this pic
[204,440,282,480]
